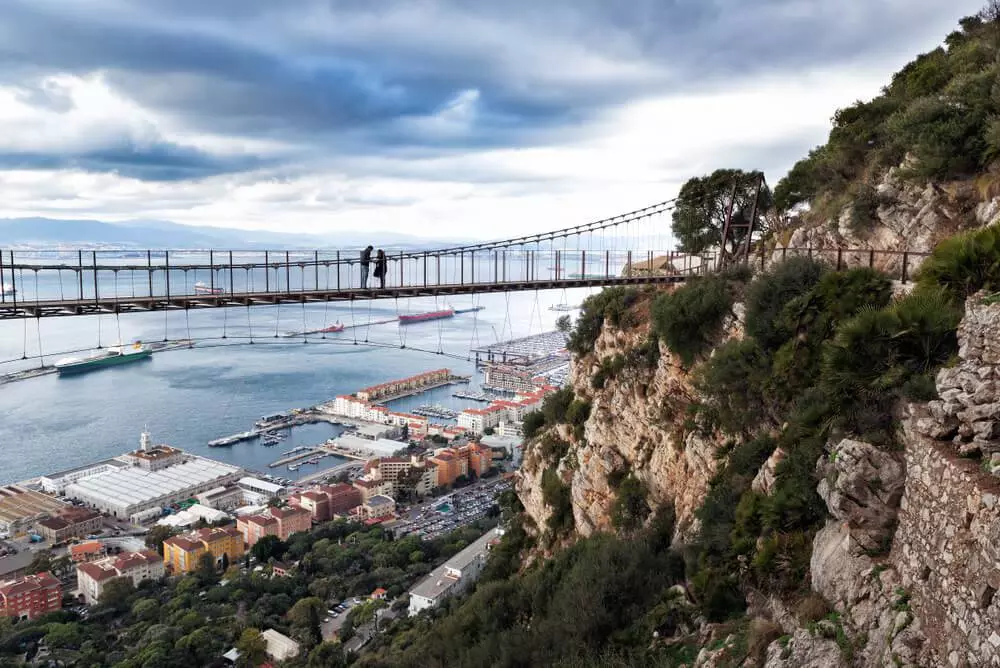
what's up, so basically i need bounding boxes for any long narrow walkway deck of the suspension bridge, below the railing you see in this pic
[0,274,690,320]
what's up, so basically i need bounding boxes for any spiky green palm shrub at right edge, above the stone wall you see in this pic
[917,225,1000,303]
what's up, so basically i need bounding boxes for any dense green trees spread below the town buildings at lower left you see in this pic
[0,521,498,668]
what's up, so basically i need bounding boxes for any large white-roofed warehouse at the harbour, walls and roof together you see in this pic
[65,454,242,521]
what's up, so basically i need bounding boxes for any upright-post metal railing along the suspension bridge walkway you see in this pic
[0,248,715,308]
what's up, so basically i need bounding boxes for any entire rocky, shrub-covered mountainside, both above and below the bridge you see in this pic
[361,6,1000,666]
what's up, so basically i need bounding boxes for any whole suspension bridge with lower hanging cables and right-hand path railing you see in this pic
[0,193,923,378]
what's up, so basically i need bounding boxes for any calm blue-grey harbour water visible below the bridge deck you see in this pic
[0,290,589,483]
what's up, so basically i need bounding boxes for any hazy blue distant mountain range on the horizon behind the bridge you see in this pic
[0,218,462,249]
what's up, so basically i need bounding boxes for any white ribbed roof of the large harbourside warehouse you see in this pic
[66,457,239,508]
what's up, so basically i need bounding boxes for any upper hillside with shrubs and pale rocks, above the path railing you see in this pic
[774,9,1000,270]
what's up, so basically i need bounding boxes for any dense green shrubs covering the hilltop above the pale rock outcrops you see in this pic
[774,8,1000,217]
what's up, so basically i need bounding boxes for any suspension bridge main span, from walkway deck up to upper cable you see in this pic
[0,200,716,320]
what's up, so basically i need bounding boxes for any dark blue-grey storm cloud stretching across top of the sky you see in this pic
[0,0,969,178]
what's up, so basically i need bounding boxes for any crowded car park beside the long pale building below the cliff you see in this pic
[392,480,511,540]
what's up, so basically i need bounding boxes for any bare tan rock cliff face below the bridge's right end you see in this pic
[517,305,742,538]
